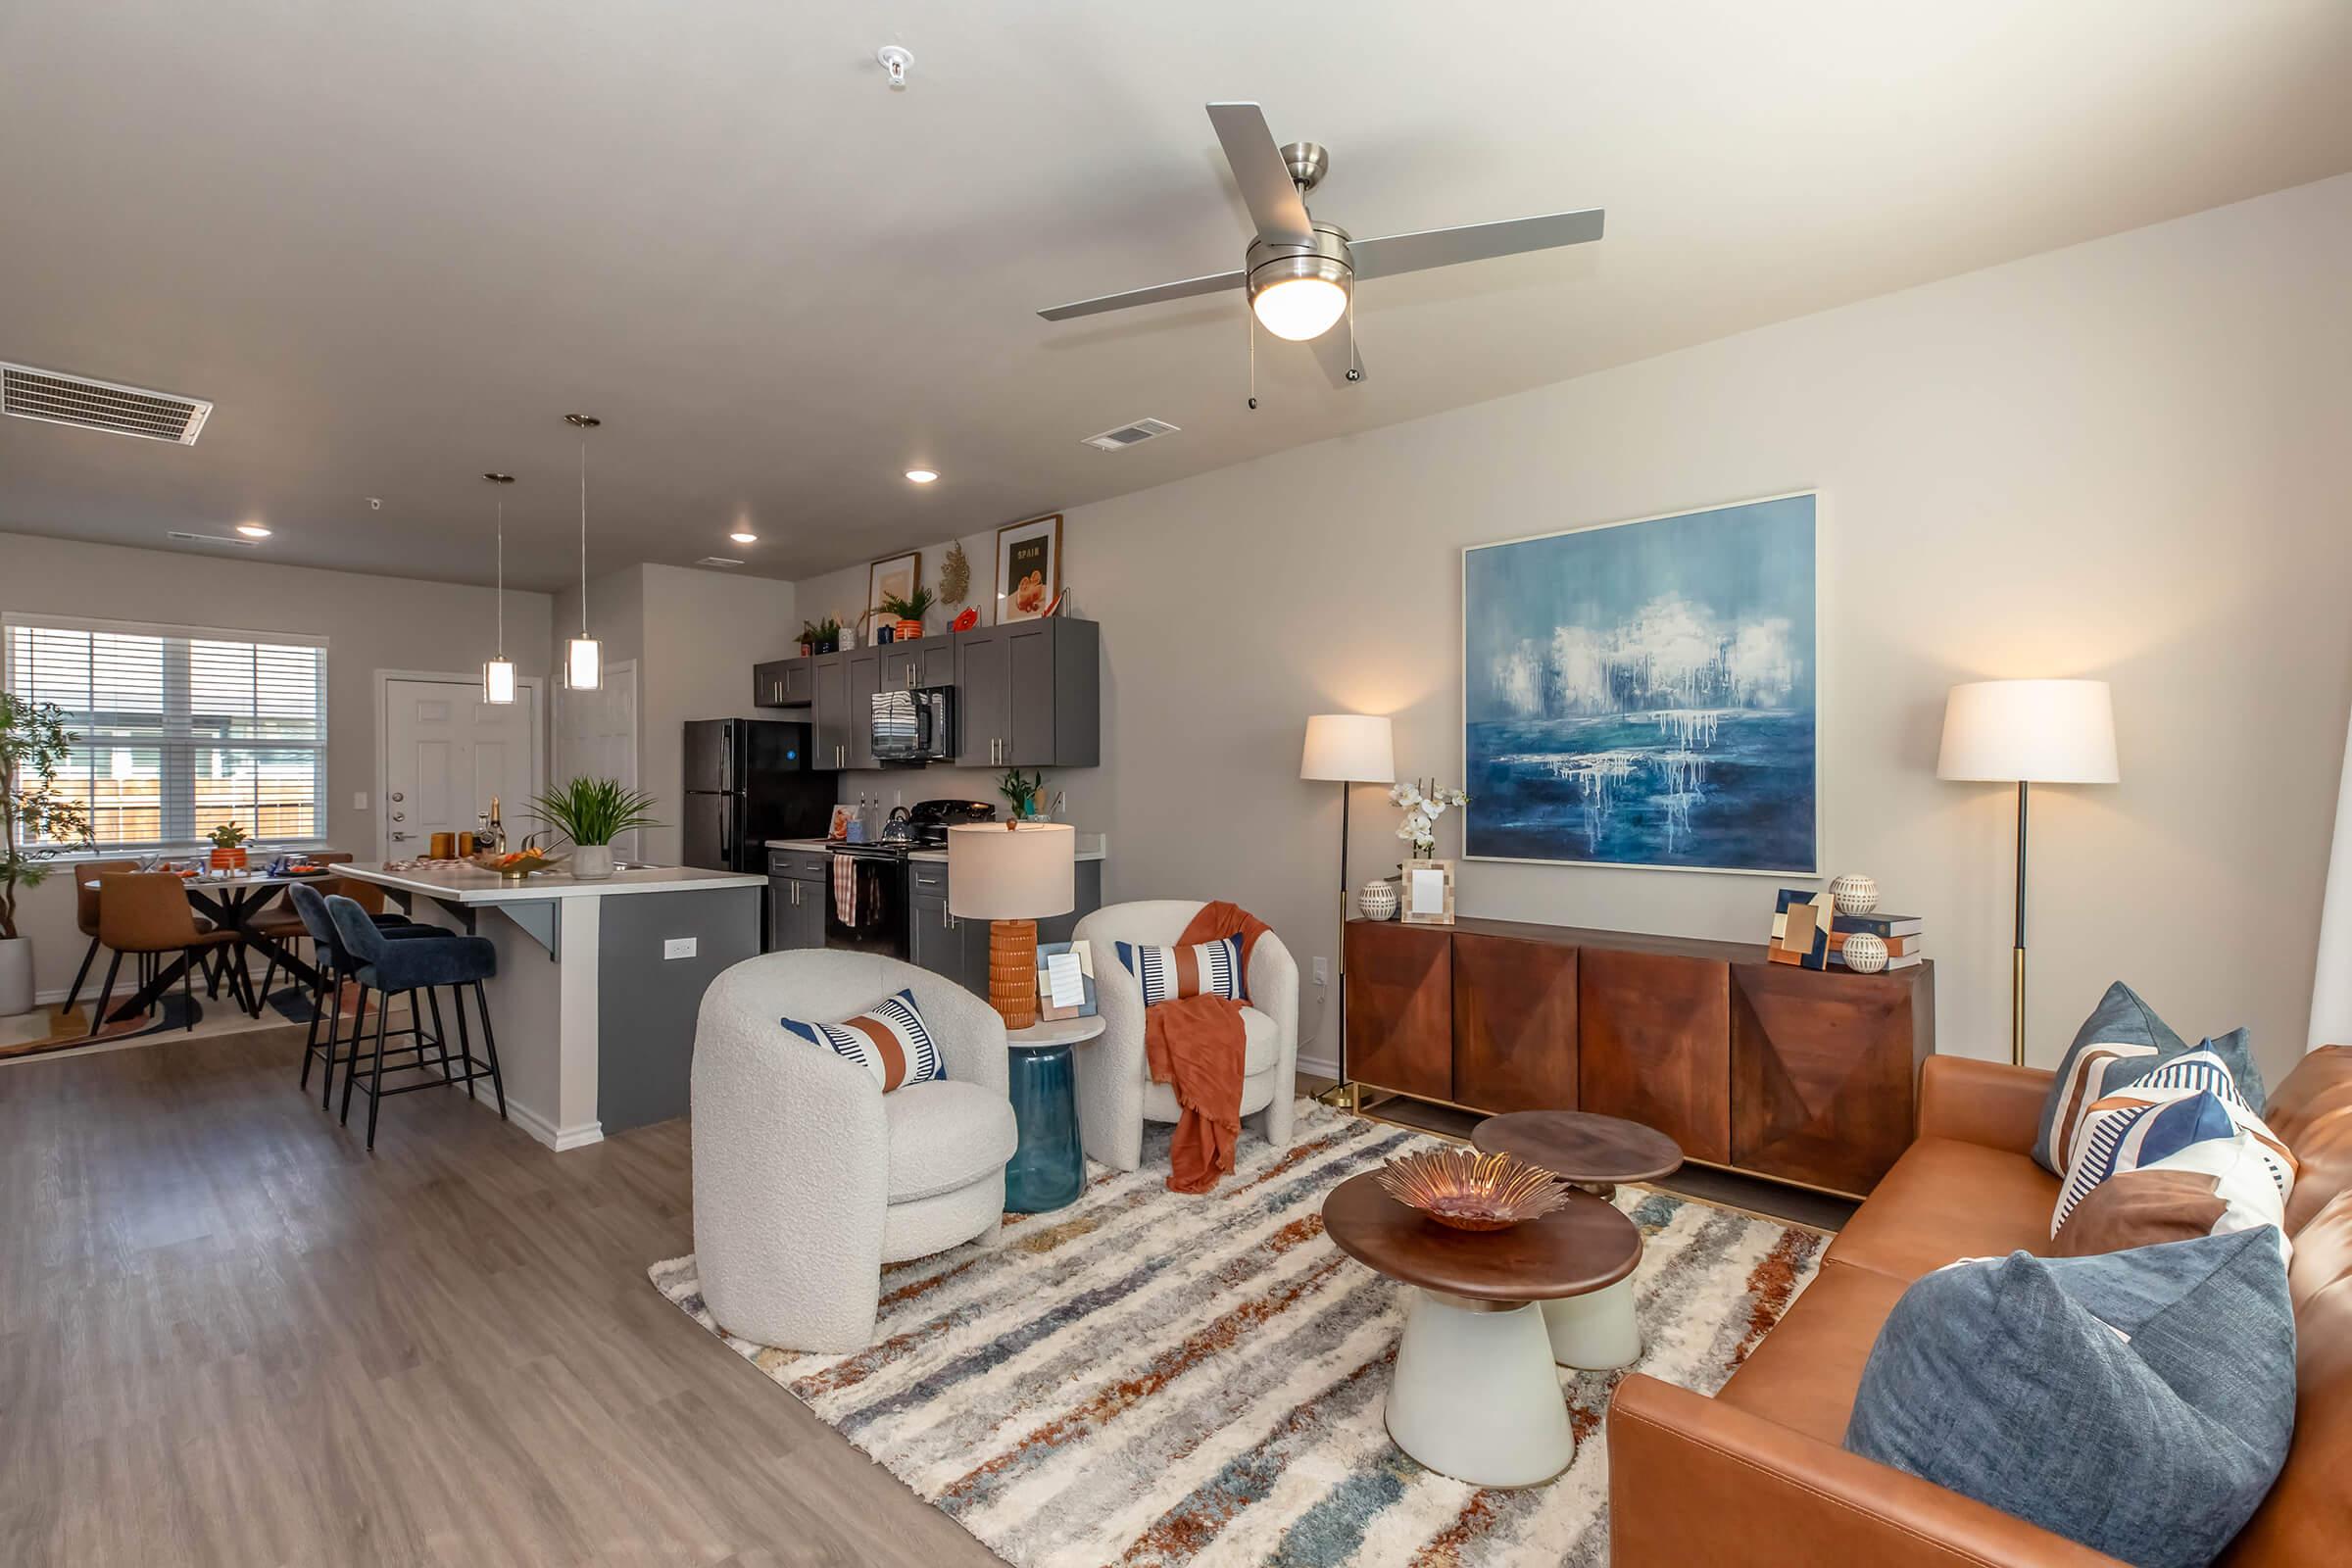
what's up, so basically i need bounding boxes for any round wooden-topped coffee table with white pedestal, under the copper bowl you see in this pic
[1324,1171,1642,1486]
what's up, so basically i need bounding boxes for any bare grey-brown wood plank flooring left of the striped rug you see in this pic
[0,1030,998,1568]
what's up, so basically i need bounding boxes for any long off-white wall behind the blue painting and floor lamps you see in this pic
[800,176,2352,1074]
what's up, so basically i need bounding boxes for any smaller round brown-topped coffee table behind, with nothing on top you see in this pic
[1470,1109,1682,1371]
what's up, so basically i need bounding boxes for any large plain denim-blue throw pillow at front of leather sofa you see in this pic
[1846,1225,2295,1568]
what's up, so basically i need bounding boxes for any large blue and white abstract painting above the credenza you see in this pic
[1463,494,1818,874]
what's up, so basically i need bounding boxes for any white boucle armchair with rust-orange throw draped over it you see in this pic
[1072,898,1298,1171]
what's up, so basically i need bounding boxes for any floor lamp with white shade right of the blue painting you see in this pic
[1936,679,2119,1065]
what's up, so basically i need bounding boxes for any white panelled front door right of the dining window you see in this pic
[381,679,539,860]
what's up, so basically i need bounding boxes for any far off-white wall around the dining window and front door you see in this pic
[0,534,551,992]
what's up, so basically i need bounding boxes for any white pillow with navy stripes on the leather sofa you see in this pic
[2051,1051,2295,1250]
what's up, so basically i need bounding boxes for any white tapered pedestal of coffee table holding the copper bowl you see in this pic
[1388,1291,1576,1486]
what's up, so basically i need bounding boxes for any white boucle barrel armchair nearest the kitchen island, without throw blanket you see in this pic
[692,950,1018,1351]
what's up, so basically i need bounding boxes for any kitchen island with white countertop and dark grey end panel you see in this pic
[336,862,766,1150]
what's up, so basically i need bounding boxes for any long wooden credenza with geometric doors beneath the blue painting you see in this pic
[1348,919,1936,1195]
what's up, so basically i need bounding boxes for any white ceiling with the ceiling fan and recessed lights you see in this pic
[0,0,2352,588]
